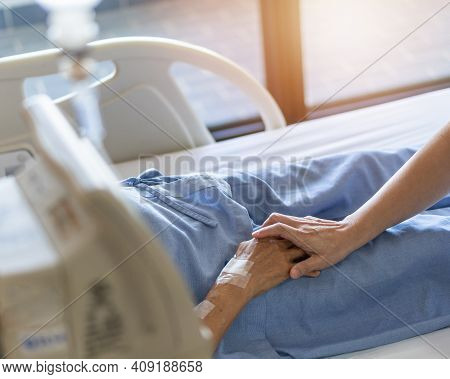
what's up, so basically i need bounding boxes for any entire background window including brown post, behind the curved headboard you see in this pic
[0,0,450,139]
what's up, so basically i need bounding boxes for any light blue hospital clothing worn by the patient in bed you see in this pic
[123,149,450,358]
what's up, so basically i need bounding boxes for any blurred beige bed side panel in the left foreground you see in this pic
[0,95,211,358]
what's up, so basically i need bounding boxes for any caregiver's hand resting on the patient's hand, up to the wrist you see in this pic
[253,213,359,279]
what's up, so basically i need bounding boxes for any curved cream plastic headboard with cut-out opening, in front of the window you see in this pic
[0,37,286,162]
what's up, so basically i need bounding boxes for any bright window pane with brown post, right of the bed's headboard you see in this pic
[261,0,450,123]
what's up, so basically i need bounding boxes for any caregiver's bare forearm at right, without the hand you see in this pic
[345,123,450,245]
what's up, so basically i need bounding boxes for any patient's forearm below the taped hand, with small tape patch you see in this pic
[196,284,249,349]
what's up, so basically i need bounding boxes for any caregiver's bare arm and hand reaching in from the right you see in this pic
[253,123,450,279]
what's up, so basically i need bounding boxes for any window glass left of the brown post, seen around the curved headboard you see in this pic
[0,0,264,140]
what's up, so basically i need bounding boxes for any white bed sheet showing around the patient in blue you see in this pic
[115,89,450,358]
